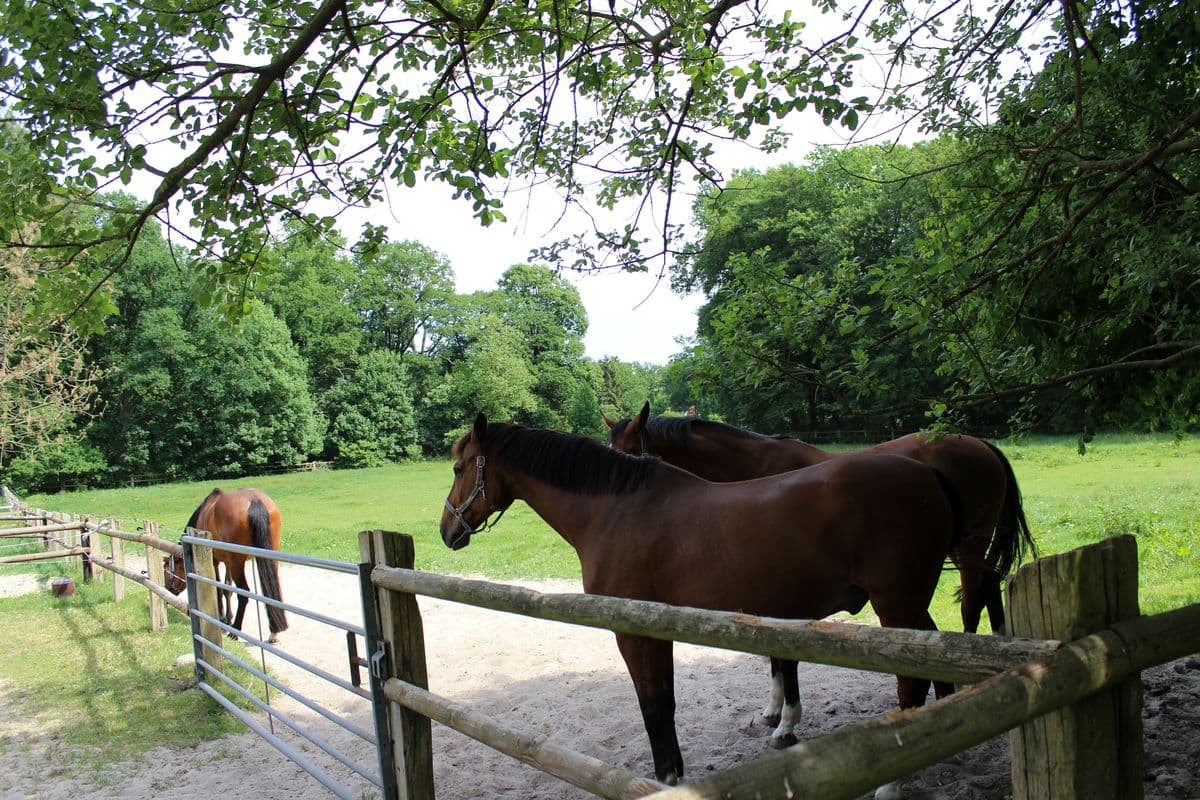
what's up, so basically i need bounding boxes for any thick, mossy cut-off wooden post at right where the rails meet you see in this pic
[1008,536,1144,800]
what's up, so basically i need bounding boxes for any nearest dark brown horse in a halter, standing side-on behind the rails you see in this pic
[440,414,960,783]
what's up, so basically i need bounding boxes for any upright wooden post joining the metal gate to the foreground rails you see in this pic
[359,530,433,800]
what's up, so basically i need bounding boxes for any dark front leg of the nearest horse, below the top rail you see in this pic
[617,633,683,786]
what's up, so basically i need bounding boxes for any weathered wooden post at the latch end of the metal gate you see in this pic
[359,530,433,800]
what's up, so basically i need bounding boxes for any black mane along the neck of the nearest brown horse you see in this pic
[484,422,659,494]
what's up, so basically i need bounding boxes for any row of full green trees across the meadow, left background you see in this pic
[2,219,665,491]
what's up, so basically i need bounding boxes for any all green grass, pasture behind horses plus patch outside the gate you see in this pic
[0,435,1200,769]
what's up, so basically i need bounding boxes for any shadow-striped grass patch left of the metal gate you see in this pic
[0,563,259,781]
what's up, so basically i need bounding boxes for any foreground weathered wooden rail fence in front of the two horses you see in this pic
[360,531,1200,800]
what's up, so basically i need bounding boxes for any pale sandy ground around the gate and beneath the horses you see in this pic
[0,565,1200,800]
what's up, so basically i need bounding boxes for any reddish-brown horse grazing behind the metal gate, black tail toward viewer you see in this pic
[163,488,288,642]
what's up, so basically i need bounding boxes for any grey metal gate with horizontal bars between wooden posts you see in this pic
[180,529,397,800]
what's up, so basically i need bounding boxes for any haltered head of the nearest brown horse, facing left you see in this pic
[440,411,508,551]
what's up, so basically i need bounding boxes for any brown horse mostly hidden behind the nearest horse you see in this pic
[601,403,1037,633]
